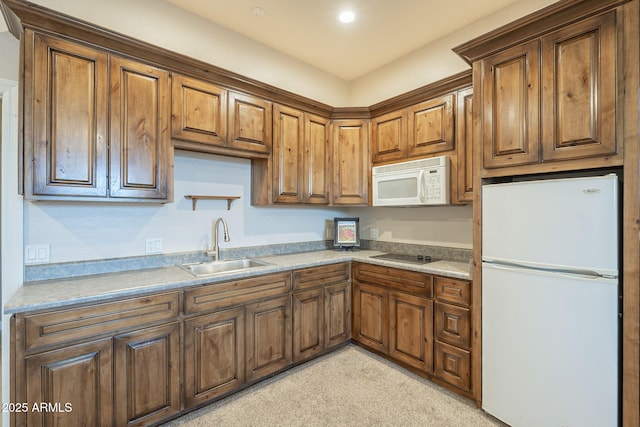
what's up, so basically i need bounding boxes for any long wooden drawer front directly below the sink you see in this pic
[184,272,291,314]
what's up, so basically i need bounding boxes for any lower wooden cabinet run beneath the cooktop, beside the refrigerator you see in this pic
[352,262,475,399]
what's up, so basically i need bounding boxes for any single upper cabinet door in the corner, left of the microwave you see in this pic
[333,120,370,205]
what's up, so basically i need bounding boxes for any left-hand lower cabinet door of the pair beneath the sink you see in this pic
[184,308,245,408]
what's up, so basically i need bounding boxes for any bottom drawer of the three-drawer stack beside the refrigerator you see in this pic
[433,340,471,391]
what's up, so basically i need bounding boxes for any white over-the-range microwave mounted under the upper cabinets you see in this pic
[371,156,449,206]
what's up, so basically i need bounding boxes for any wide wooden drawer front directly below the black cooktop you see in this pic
[354,263,433,298]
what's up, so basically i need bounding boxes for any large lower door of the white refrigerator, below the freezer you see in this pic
[482,263,618,427]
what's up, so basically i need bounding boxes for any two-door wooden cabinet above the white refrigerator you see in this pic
[474,10,622,176]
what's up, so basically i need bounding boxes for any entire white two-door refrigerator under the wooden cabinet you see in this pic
[482,174,619,427]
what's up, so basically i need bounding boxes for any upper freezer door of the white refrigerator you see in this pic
[482,175,618,276]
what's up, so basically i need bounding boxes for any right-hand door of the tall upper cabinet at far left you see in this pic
[110,57,173,201]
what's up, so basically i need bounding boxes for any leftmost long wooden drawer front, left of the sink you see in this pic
[24,292,179,352]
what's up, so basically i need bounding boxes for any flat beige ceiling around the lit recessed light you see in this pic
[164,0,517,81]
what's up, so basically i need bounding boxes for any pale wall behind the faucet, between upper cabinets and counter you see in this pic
[24,151,344,263]
